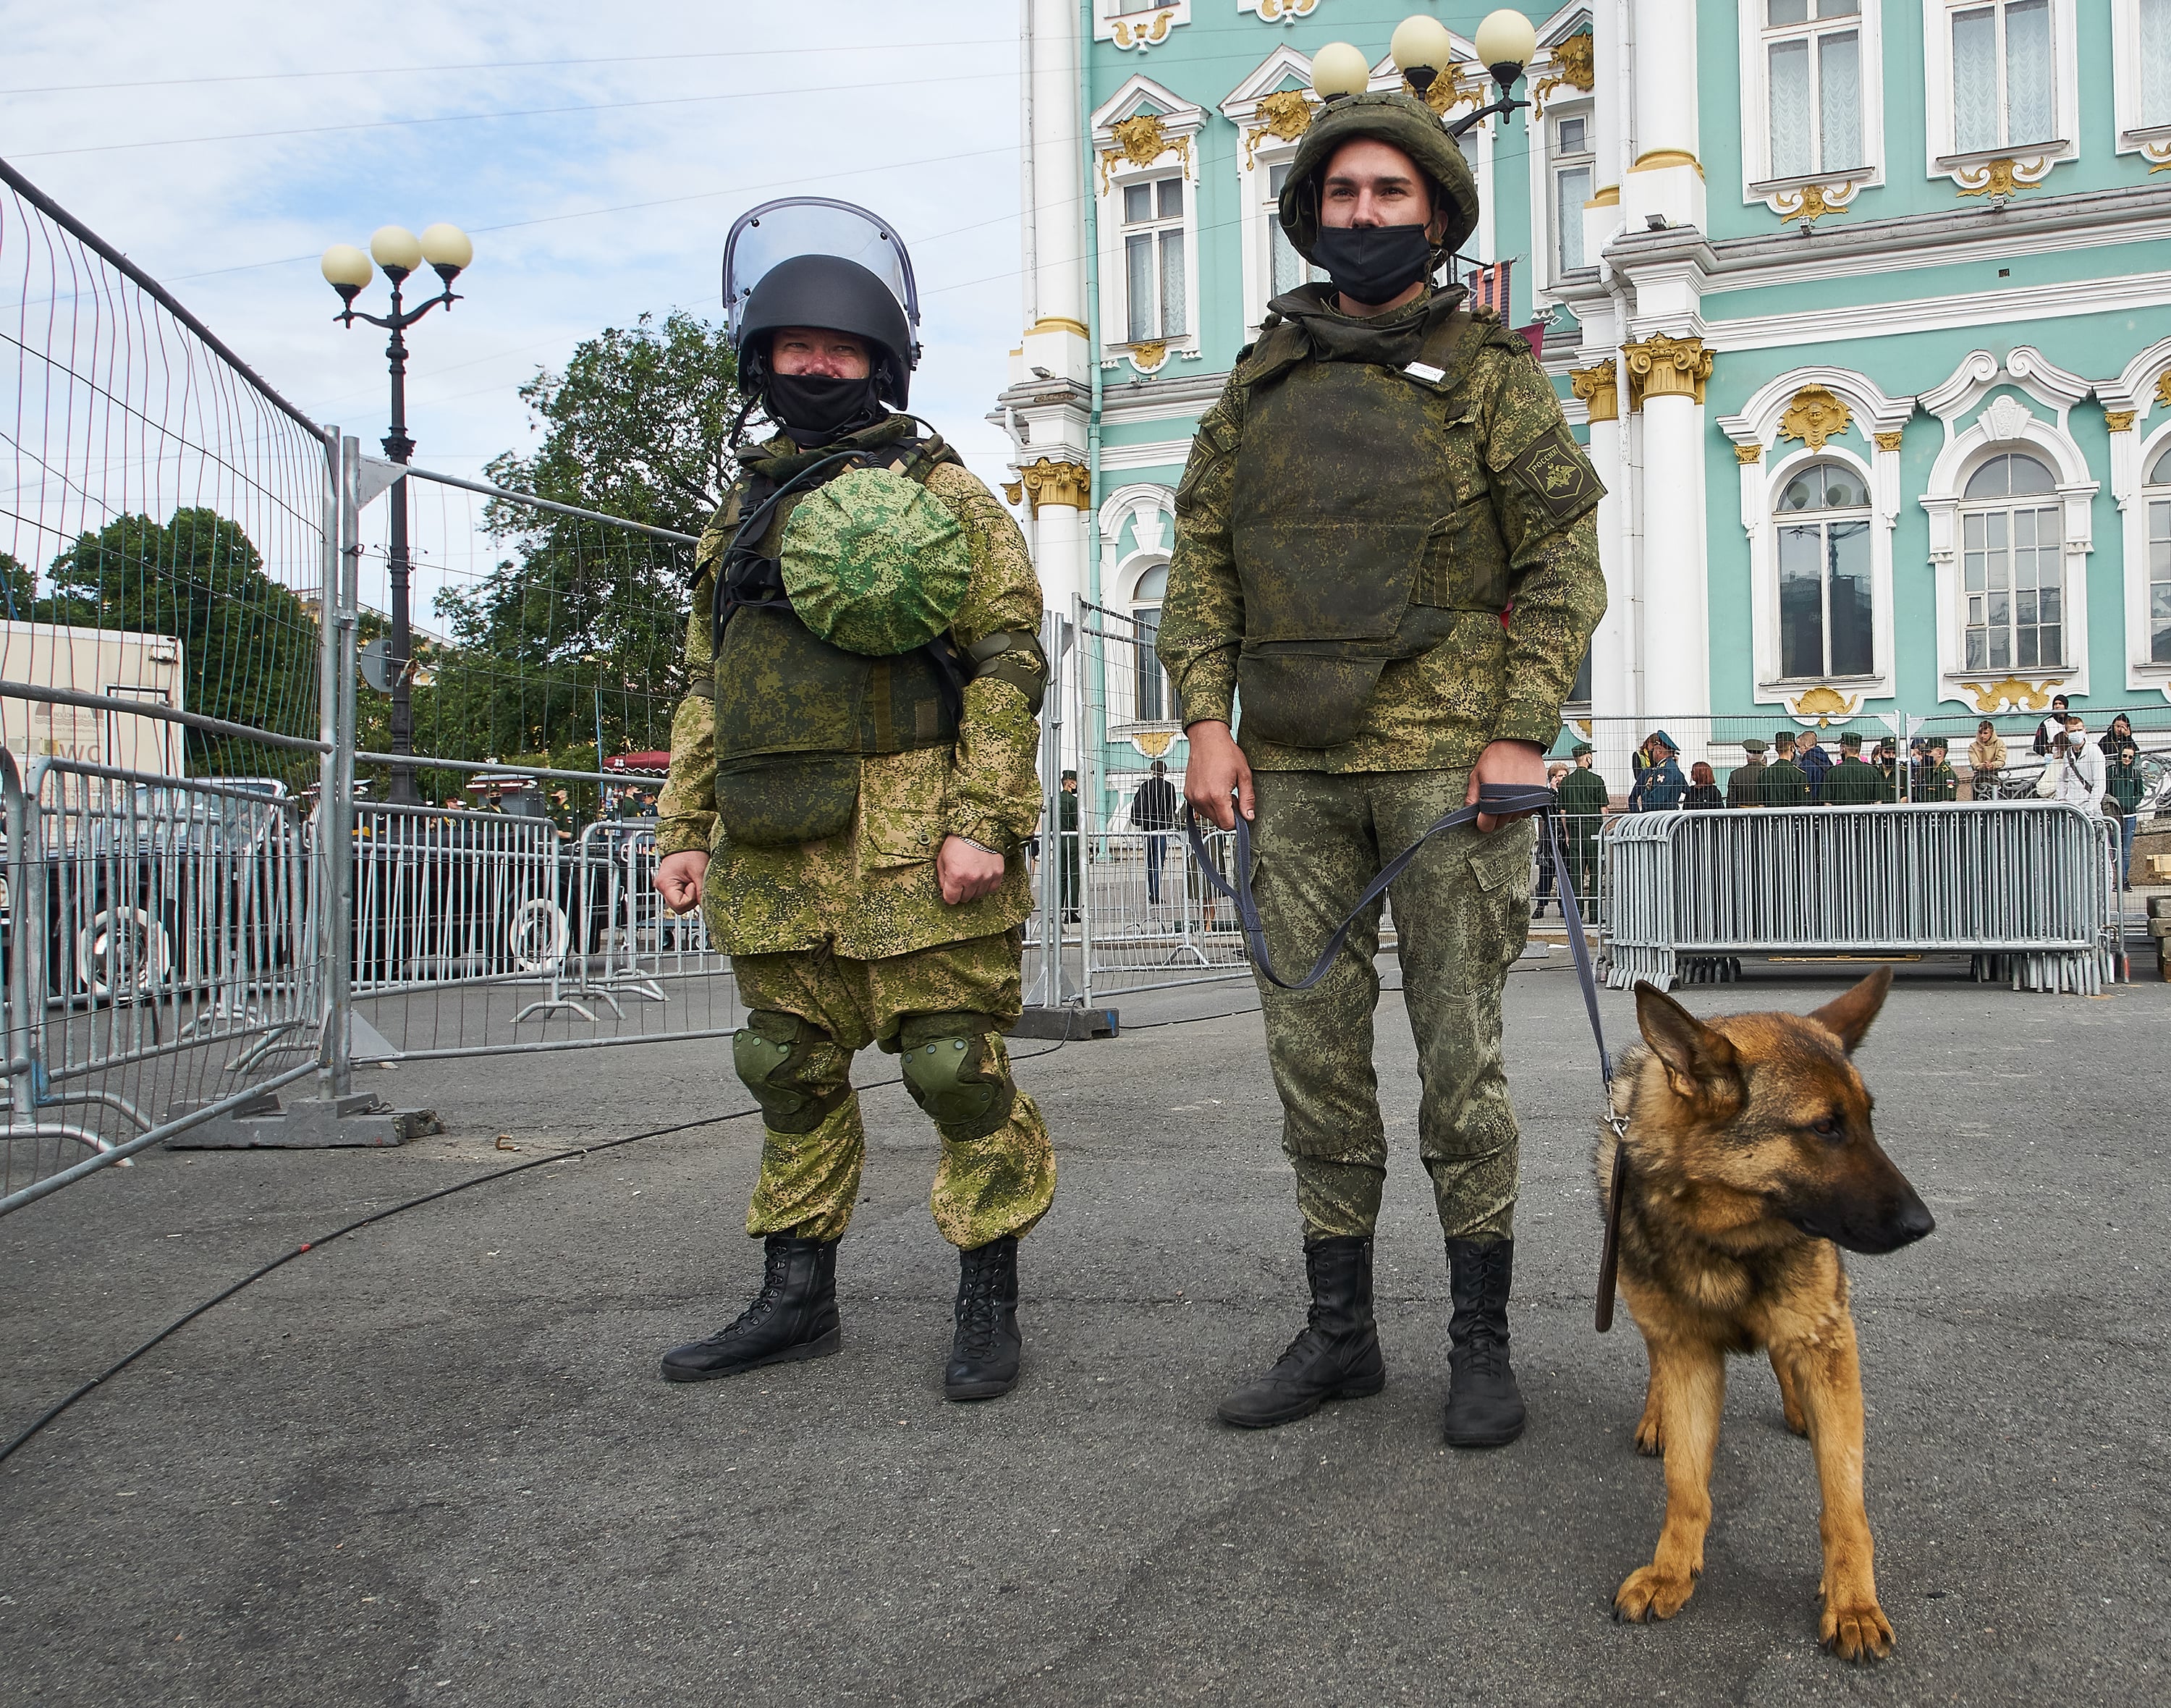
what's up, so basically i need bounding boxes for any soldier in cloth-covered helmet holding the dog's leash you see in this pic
[1159,77,1607,1447]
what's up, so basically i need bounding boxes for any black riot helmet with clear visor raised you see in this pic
[723,195,921,410]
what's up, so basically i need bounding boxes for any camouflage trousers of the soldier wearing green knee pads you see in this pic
[732,931,1055,1250]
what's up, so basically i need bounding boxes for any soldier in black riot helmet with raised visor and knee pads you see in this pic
[656,202,1055,1400]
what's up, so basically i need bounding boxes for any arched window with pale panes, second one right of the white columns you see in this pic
[1960,452,2065,671]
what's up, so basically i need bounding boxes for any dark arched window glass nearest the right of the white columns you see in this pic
[1774,462,1876,682]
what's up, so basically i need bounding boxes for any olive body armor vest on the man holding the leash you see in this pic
[1231,313,1507,747]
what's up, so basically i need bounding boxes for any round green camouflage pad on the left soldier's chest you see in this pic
[779,469,973,658]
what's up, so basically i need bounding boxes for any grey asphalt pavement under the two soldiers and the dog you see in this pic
[0,952,2171,1708]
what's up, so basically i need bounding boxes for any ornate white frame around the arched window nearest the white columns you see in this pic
[1719,367,1915,712]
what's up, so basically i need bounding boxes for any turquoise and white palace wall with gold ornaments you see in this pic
[1001,0,2171,807]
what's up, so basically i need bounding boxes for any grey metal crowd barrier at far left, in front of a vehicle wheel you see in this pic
[0,756,323,1211]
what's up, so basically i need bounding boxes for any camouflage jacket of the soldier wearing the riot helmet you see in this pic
[656,417,1040,959]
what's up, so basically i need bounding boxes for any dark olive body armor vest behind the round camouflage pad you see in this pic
[714,439,962,849]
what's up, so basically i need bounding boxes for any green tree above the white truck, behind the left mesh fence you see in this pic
[37,506,317,773]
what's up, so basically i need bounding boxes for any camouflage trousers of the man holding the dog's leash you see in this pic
[1253,771,1537,1239]
